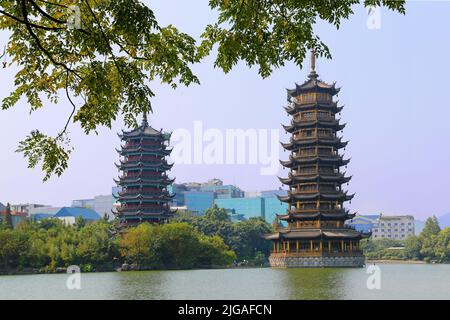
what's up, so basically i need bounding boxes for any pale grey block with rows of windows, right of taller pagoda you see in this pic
[372,215,415,240]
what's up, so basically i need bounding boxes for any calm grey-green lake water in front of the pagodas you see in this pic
[0,264,450,300]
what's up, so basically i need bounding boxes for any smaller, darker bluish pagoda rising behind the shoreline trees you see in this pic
[114,114,174,227]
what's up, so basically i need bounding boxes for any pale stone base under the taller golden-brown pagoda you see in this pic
[269,255,366,268]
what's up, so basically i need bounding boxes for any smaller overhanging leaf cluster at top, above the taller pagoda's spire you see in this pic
[199,0,405,77]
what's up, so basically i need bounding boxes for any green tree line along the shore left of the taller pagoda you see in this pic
[0,207,272,273]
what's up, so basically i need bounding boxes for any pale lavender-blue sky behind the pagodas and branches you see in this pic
[0,0,450,218]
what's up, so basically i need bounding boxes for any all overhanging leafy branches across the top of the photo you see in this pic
[0,0,405,180]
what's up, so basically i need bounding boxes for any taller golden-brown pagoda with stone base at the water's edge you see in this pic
[266,51,365,268]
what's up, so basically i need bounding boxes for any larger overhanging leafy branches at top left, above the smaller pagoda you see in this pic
[0,0,199,180]
